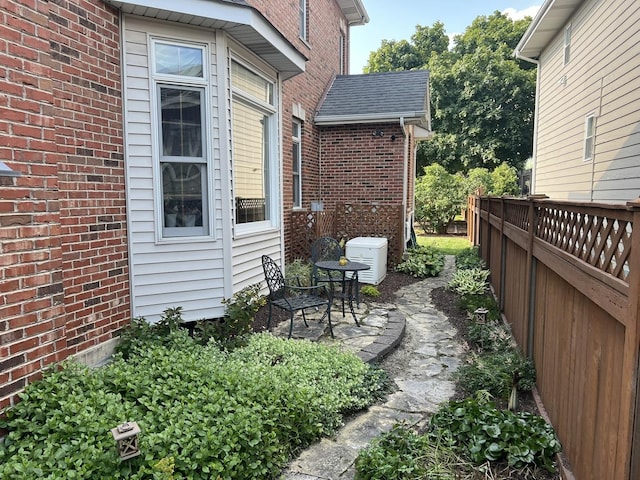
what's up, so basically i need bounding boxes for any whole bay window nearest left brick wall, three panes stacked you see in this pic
[152,39,210,238]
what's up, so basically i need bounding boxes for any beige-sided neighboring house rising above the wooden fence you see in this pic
[515,0,640,203]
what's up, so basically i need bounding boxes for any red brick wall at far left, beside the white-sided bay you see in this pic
[0,0,130,410]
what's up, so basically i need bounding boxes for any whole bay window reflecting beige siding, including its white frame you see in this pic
[231,60,278,231]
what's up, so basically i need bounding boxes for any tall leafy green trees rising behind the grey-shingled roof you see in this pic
[365,11,536,173]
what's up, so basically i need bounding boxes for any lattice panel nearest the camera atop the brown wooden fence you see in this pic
[535,206,633,281]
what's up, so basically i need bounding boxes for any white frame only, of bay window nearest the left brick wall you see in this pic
[149,37,214,241]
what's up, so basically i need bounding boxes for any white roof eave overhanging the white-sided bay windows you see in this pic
[104,0,307,79]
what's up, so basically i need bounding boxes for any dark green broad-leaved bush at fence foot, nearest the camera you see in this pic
[429,395,561,472]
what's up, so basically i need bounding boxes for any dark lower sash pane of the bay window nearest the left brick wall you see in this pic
[162,163,207,228]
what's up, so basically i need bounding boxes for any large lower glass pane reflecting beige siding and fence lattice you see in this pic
[233,101,269,223]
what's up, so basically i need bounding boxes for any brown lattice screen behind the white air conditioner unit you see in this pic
[287,203,404,265]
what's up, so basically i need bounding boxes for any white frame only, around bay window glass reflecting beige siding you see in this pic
[228,56,281,238]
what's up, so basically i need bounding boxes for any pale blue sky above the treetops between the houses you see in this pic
[349,0,542,74]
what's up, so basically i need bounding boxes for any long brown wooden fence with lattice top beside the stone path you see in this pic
[468,197,640,480]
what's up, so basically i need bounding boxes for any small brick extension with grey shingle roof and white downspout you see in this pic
[315,70,431,244]
